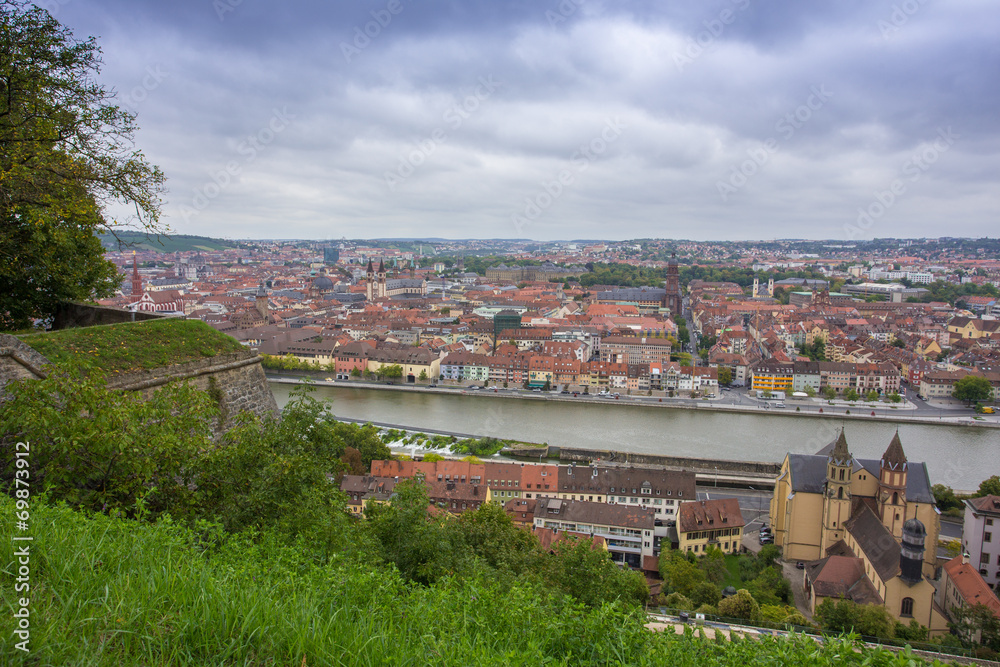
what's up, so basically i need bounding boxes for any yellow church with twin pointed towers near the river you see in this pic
[770,430,948,635]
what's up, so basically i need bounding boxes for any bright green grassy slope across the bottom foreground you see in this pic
[0,496,952,667]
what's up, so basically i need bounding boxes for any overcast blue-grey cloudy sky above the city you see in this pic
[52,0,1000,240]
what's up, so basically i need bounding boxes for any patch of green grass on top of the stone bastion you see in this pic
[18,318,243,375]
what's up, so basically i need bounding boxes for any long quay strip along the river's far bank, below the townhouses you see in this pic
[267,373,1000,428]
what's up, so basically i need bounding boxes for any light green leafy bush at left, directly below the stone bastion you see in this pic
[0,368,218,517]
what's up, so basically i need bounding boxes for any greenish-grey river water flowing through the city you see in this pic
[271,383,1000,490]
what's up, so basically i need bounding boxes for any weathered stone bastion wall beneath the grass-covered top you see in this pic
[0,334,278,427]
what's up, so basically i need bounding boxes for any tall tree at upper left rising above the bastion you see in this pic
[0,0,164,329]
